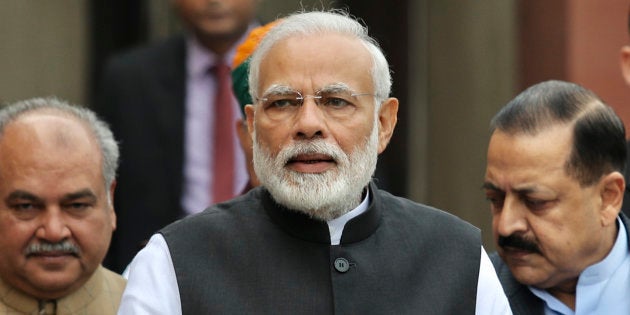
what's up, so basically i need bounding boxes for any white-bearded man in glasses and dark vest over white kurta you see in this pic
[119,11,511,314]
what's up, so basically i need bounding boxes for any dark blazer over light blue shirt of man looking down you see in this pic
[490,213,630,315]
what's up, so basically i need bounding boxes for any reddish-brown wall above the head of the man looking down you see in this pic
[518,0,630,135]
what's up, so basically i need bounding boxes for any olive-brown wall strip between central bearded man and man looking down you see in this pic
[407,0,516,248]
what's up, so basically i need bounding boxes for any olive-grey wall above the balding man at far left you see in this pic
[0,0,89,103]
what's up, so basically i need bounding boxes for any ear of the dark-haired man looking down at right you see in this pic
[600,172,626,226]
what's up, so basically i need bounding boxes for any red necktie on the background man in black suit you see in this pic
[212,62,236,203]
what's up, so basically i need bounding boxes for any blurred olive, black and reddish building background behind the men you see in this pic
[0,0,630,249]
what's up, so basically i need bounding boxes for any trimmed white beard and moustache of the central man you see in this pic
[254,120,378,221]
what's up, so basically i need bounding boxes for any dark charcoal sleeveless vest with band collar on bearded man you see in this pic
[160,184,481,315]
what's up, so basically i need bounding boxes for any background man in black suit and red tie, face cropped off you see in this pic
[95,0,260,271]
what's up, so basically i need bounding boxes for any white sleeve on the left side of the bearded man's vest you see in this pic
[118,234,182,315]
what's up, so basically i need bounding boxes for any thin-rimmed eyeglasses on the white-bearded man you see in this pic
[257,89,374,121]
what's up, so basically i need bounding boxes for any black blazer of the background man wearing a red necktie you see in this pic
[94,35,186,272]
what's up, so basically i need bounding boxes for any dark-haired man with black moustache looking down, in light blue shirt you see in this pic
[484,81,630,314]
